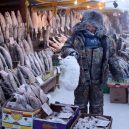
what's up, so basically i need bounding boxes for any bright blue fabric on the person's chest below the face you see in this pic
[84,31,101,49]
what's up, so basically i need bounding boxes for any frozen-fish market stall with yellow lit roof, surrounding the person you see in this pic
[0,0,129,129]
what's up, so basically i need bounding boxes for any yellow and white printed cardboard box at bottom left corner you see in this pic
[2,97,48,129]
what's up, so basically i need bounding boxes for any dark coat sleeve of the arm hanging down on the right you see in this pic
[108,36,125,81]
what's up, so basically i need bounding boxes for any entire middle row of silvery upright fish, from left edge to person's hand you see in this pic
[0,43,53,73]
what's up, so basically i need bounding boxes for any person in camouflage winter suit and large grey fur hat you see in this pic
[61,10,122,114]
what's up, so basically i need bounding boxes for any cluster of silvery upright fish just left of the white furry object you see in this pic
[24,48,53,76]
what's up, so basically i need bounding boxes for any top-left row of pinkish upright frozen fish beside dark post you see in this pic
[0,11,27,44]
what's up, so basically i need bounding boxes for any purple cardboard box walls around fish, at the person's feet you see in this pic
[33,104,79,129]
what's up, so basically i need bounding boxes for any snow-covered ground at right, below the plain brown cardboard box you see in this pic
[48,94,129,129]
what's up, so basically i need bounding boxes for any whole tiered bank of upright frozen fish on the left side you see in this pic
[0,11,53,115]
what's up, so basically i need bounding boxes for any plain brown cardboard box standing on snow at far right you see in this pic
[110,87,128,103]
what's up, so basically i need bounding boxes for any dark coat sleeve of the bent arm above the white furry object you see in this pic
[61,35,79,58]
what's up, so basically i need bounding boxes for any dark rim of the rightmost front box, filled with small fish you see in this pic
[70,114,112,129]
